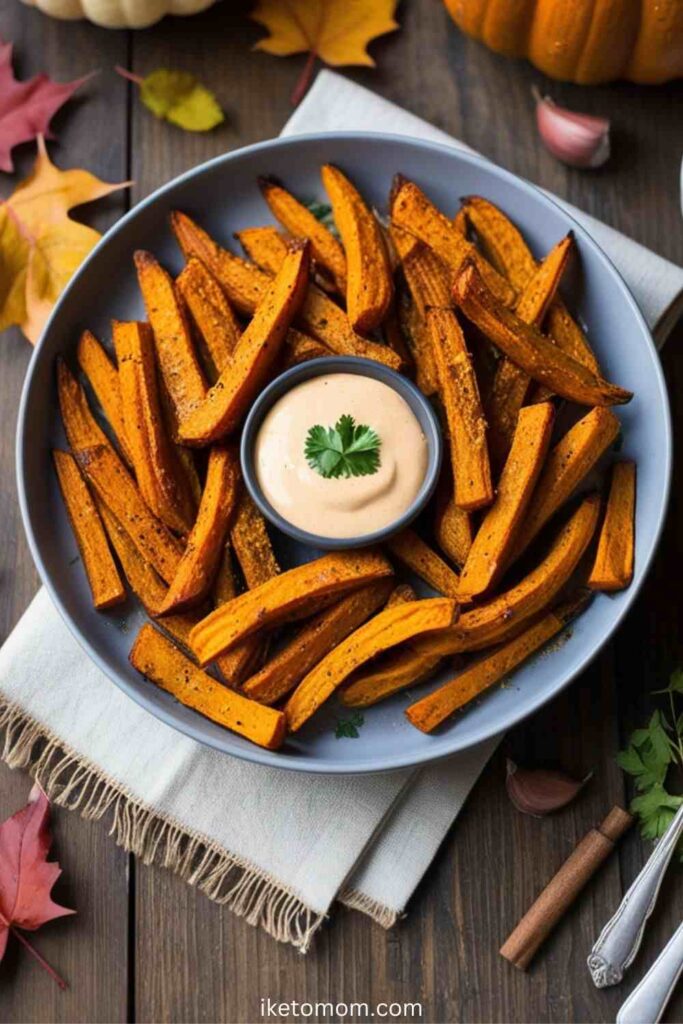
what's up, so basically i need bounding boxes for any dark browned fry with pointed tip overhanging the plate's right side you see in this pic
[454,263,633,406]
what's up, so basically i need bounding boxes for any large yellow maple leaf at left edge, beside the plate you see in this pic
[0,135,130,345]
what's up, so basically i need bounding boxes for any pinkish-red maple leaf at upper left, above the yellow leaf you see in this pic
[0,38,90,171]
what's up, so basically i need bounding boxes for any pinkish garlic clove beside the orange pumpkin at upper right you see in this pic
[533,88,609,167]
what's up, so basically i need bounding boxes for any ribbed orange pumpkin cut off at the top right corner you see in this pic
[444,0,683,85]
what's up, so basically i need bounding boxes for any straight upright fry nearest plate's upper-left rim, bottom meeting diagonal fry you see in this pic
[134,250,207,422]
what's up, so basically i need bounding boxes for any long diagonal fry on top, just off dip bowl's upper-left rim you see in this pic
[179,243,308,444]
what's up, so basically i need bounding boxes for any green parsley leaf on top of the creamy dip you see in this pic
[304,416,382,479]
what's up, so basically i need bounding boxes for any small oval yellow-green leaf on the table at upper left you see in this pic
[140,68,224,131]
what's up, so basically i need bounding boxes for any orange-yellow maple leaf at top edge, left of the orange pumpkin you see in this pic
[250,0,398,103]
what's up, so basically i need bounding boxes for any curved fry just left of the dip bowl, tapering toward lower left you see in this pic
[159,445,240,614]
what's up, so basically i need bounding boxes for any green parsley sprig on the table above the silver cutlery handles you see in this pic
[616,669,683,860]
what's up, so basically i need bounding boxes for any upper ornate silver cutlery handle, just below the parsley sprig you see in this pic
[588,804,683,988]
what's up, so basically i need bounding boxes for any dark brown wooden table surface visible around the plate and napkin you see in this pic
[0,0,683,1022]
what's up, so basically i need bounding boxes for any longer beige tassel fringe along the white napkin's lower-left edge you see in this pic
[0,703,325,952]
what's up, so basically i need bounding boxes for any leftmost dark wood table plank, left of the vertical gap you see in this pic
[0,3,128,1024]
